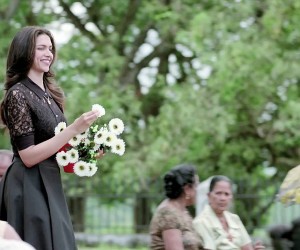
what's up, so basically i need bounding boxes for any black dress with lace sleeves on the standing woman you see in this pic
[0,79,77,250]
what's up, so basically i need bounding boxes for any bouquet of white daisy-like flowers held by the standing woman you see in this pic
[55,104,125,177]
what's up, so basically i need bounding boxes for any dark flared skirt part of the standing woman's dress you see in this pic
[0,157,77,250]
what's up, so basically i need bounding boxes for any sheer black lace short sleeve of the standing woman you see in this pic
[6,89,34,139]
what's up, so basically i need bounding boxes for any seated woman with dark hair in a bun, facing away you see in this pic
[150,165,202,250]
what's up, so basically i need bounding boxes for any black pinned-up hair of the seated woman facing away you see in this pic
[164,164,196,199]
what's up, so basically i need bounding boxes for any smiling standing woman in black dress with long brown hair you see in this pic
[0,26,99,250]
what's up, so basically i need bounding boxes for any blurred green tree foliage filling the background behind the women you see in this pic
[0,0,300,232]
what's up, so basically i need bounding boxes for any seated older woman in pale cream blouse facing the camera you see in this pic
[193,175,265,250]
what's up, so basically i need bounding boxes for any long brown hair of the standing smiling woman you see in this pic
[0,26,64,125]
